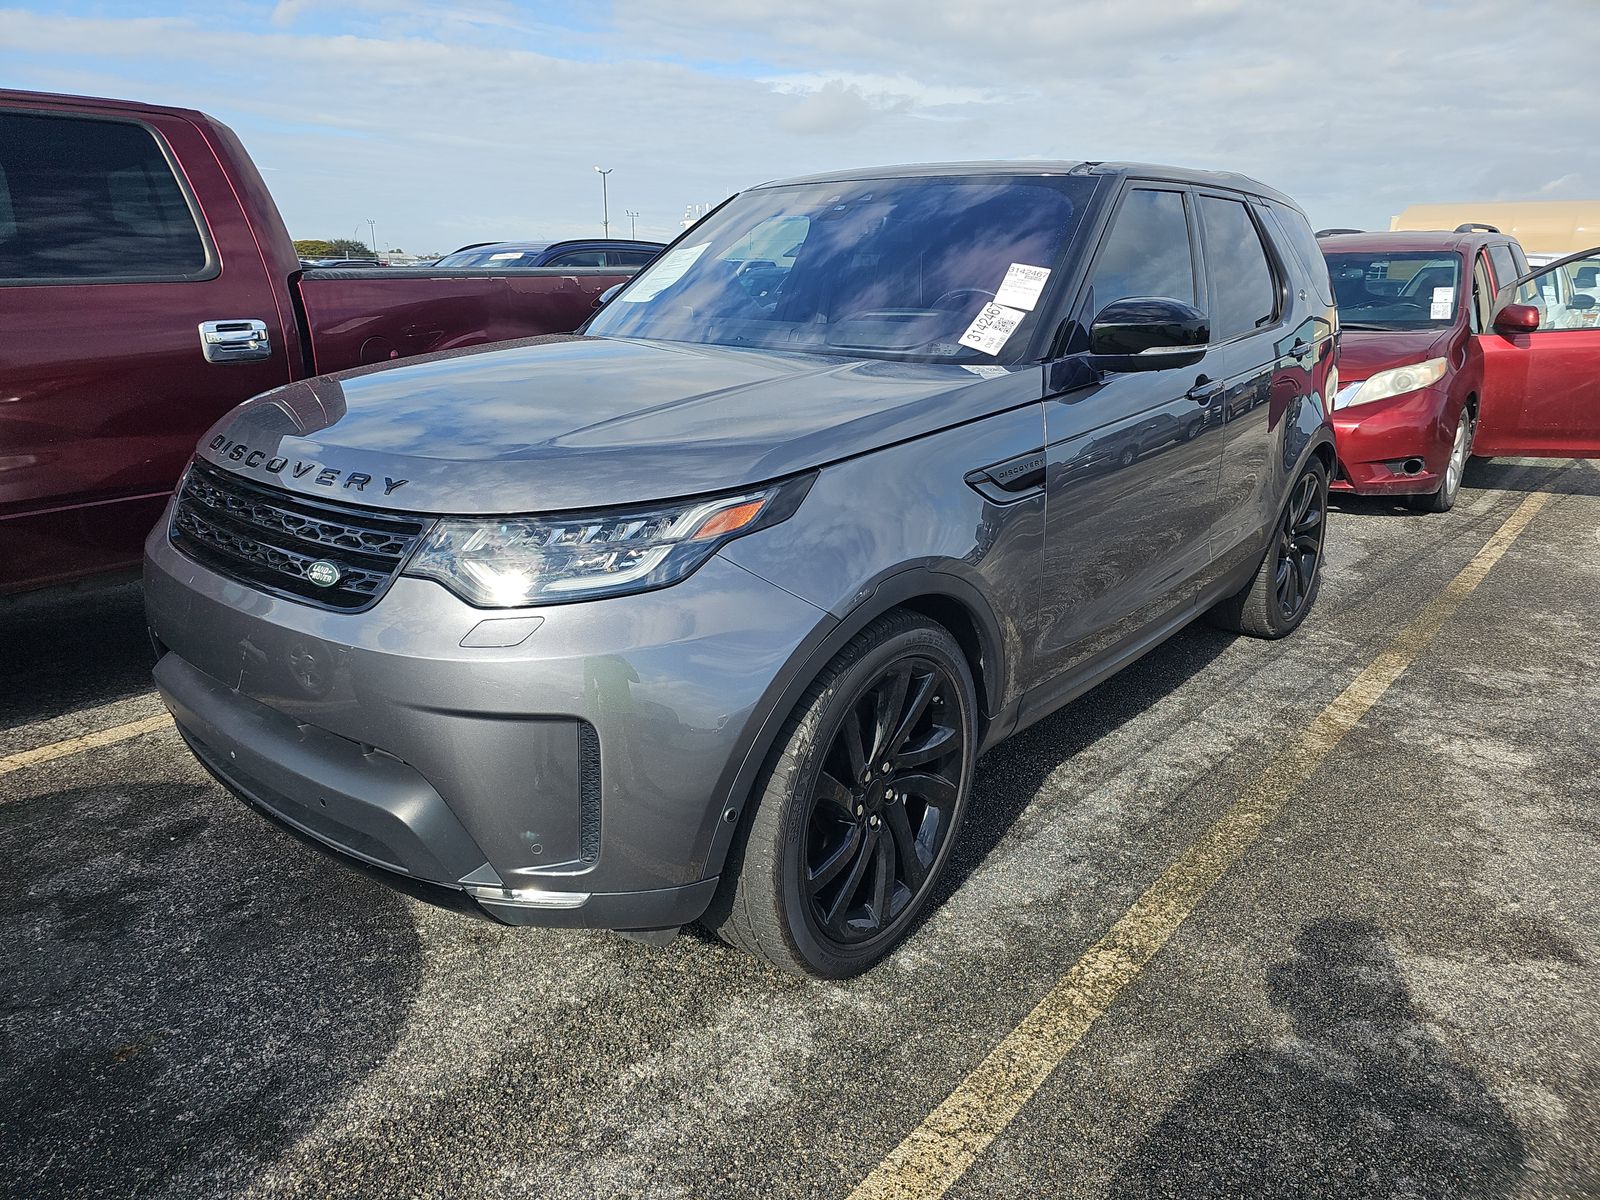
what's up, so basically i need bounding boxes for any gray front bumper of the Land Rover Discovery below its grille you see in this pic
[146,523,830,930]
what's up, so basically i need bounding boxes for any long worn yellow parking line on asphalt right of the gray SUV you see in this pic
[850,493,1550,1200]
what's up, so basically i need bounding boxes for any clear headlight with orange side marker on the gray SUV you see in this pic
[405,475,813,608]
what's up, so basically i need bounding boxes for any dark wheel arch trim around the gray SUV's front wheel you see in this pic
[701,565,1008,878]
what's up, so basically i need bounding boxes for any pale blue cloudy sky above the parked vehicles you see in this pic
[0,0,1600,251]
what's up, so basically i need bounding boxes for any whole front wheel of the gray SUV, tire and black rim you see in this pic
[706,611,978,979]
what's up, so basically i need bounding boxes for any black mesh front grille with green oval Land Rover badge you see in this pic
[170,459,426,613]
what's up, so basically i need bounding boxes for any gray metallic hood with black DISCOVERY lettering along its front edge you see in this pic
[200,336,1042,514]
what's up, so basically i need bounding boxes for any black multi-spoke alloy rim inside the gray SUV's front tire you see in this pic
[802,654,966,946]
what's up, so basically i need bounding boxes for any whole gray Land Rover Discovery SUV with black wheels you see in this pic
[146,163,1336,976]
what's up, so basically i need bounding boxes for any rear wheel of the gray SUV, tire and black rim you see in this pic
[1206,458,1328,638]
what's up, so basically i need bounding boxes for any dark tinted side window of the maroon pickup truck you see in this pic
[0,112,206,280]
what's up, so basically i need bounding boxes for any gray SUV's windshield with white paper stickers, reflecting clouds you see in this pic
[587,176,1094,363]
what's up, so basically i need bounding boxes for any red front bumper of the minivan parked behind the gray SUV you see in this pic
[1331,385,1459,496]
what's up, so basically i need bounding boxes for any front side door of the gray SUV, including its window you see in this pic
[1035,184,1222,706]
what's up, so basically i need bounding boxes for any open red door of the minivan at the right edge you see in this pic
[1472,246,1600,458]
